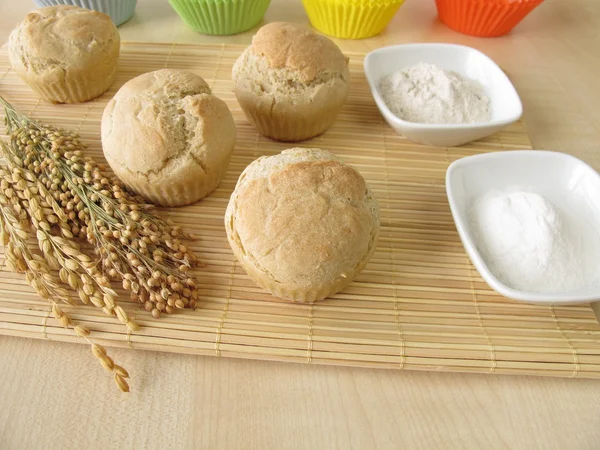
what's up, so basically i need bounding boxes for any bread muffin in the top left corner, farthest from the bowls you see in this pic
[8,5,120,103]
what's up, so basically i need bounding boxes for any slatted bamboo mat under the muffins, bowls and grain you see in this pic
[0,43,600,378]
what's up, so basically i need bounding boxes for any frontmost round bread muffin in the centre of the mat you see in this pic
[225,148,379,302]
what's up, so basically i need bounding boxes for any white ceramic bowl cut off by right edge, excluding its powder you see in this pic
[446,150,600,304]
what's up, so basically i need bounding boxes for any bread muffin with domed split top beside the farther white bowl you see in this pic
[232,22,350,141]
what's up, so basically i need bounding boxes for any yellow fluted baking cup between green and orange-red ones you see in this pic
[302,0,404,39]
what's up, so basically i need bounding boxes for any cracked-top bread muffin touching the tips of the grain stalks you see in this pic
[102,69,235,206]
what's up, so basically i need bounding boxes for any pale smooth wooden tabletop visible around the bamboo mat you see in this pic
[0,0,600,450]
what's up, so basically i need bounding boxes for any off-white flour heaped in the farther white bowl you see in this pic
[379,63,491,124]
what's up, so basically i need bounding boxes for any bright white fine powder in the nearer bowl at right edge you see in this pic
[469,190,600,293]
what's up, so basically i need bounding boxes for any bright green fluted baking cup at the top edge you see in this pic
[169,0,271,36]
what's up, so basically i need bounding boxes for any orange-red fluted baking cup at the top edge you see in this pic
[435,0,544,37]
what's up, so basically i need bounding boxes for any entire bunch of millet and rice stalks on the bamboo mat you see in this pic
[0,97,198,392]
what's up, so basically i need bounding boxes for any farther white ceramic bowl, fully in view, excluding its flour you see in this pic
[364,44,523,147]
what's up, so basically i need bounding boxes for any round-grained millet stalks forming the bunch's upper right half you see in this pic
[0,97,198,318]
